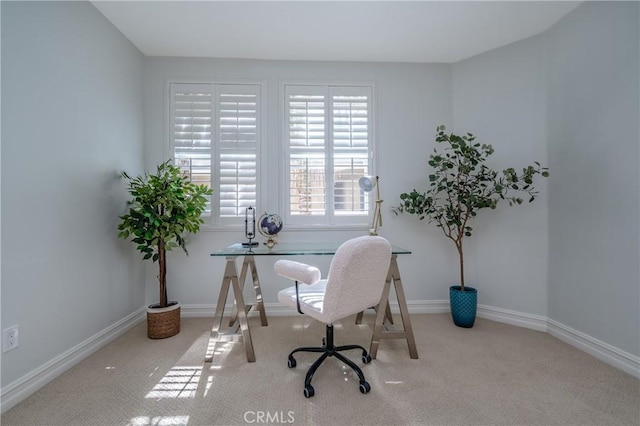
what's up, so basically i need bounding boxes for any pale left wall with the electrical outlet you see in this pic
[2,2,144,390]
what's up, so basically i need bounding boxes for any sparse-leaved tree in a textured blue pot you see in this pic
[394,126,549,327]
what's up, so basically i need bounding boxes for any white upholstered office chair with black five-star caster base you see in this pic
[274,236,391,398]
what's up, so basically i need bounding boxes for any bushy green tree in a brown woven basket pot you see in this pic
[118,160,213,339]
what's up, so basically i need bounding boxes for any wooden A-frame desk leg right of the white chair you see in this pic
[369,255,418,359]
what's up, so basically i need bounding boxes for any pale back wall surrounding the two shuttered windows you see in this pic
[145,58,456,305]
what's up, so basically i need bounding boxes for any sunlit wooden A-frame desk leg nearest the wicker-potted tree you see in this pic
[205,256,256,362]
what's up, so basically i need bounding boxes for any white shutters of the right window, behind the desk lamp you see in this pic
[284,85,373,225]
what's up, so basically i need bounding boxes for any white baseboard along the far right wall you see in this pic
[547,319,640,378]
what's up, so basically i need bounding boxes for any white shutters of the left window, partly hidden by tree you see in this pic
[170,83,261,225]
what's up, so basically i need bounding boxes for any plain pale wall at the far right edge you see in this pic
[547,2,640,356]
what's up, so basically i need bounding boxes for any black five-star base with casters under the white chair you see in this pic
[287,324,371,398]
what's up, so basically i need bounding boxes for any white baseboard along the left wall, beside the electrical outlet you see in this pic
[0,307,146,413]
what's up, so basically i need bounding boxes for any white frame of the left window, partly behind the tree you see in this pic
[163,78,267,228]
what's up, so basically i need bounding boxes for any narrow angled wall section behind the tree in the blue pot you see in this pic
[452,36,553,316]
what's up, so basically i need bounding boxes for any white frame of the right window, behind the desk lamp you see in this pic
[279,81,378,230]
